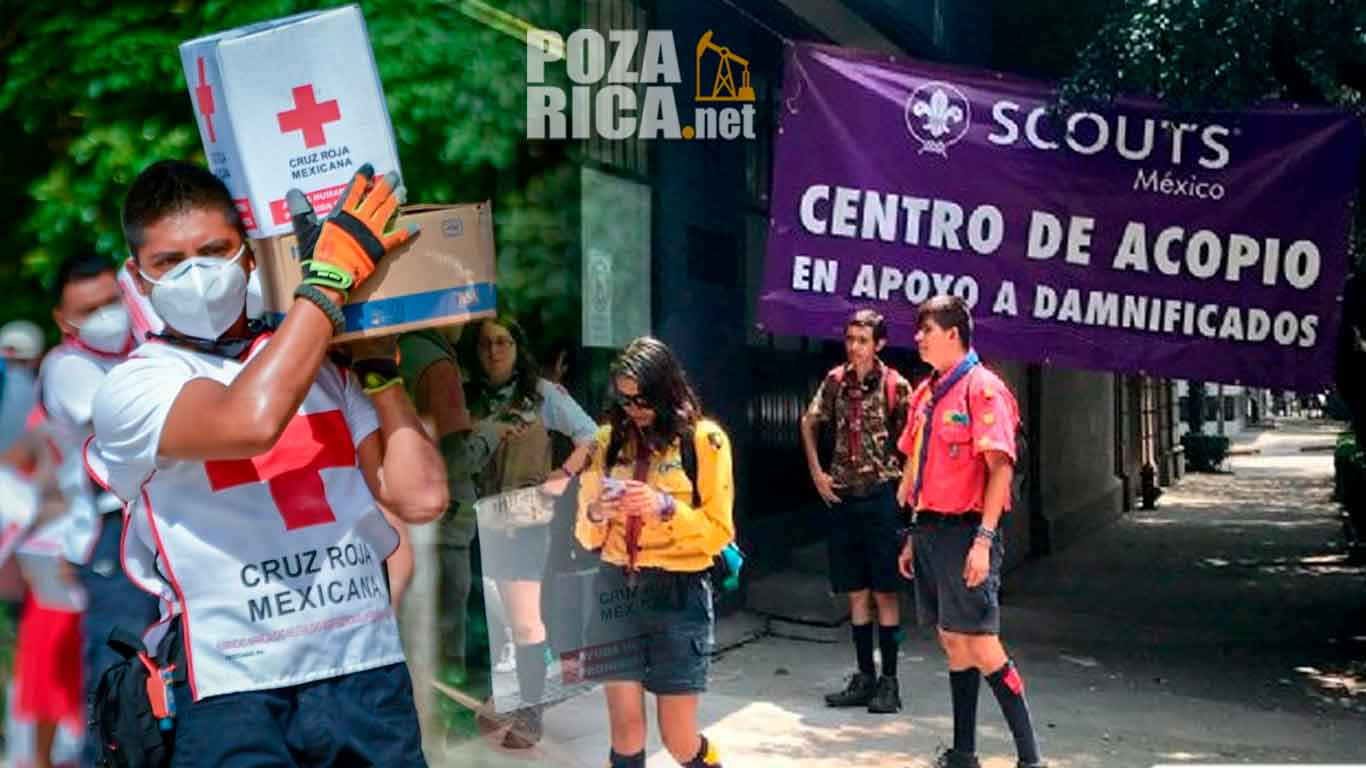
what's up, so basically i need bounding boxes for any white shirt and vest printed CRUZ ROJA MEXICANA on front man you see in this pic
[85,336,403,701]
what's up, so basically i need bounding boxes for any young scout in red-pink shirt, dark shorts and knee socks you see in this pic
[896,297,1041,768]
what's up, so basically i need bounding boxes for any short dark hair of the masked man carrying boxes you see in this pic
[123,160,247,258]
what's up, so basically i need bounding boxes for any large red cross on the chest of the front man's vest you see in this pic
[204,410,355,530]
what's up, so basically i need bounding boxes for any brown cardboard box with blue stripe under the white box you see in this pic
[251,202,497,342]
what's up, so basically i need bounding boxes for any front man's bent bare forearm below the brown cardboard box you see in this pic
[372,387,449,522]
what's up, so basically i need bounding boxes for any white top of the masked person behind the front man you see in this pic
[38,338,127,564]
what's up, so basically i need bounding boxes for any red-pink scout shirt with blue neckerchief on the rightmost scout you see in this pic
[897,364,1019,514]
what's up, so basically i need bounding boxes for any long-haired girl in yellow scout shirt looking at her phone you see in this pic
[575,338,735,768]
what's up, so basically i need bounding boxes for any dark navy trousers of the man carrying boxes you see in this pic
[171,663,426,768]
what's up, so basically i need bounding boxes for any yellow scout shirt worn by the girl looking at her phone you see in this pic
[574,420,735,573]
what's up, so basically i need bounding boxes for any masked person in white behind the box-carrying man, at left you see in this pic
[38,254,157,754]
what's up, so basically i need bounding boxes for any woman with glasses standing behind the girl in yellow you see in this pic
[464,314,597,749]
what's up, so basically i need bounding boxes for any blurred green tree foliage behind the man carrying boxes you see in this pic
[0,0,576,333]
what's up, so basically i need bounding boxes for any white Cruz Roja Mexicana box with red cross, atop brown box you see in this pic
[180,5,399,238]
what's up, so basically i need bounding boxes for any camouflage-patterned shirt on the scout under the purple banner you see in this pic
[806,361,911,489]
